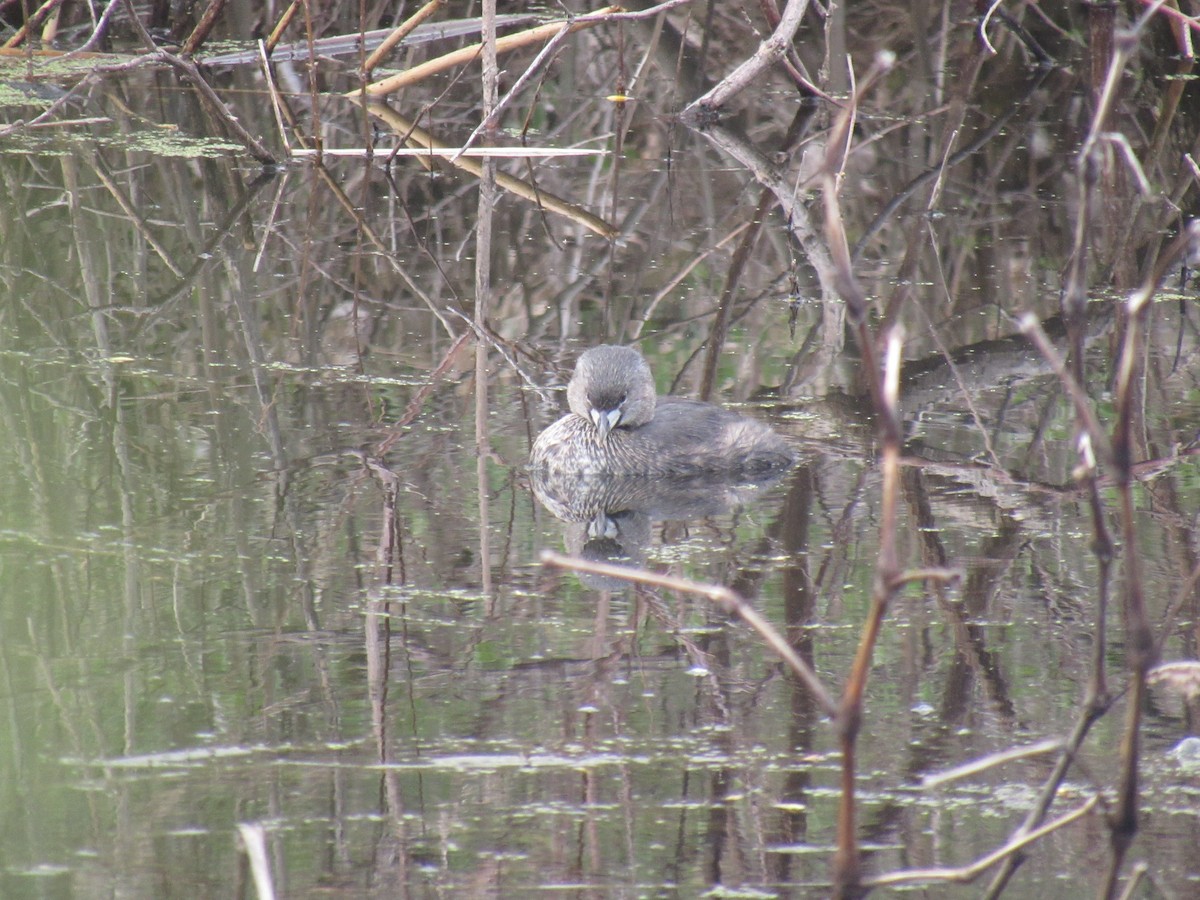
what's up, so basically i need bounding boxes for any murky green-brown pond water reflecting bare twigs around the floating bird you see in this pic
[0,4,1200,898]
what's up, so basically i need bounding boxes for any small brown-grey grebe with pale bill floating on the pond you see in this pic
[529,344,796,476]
